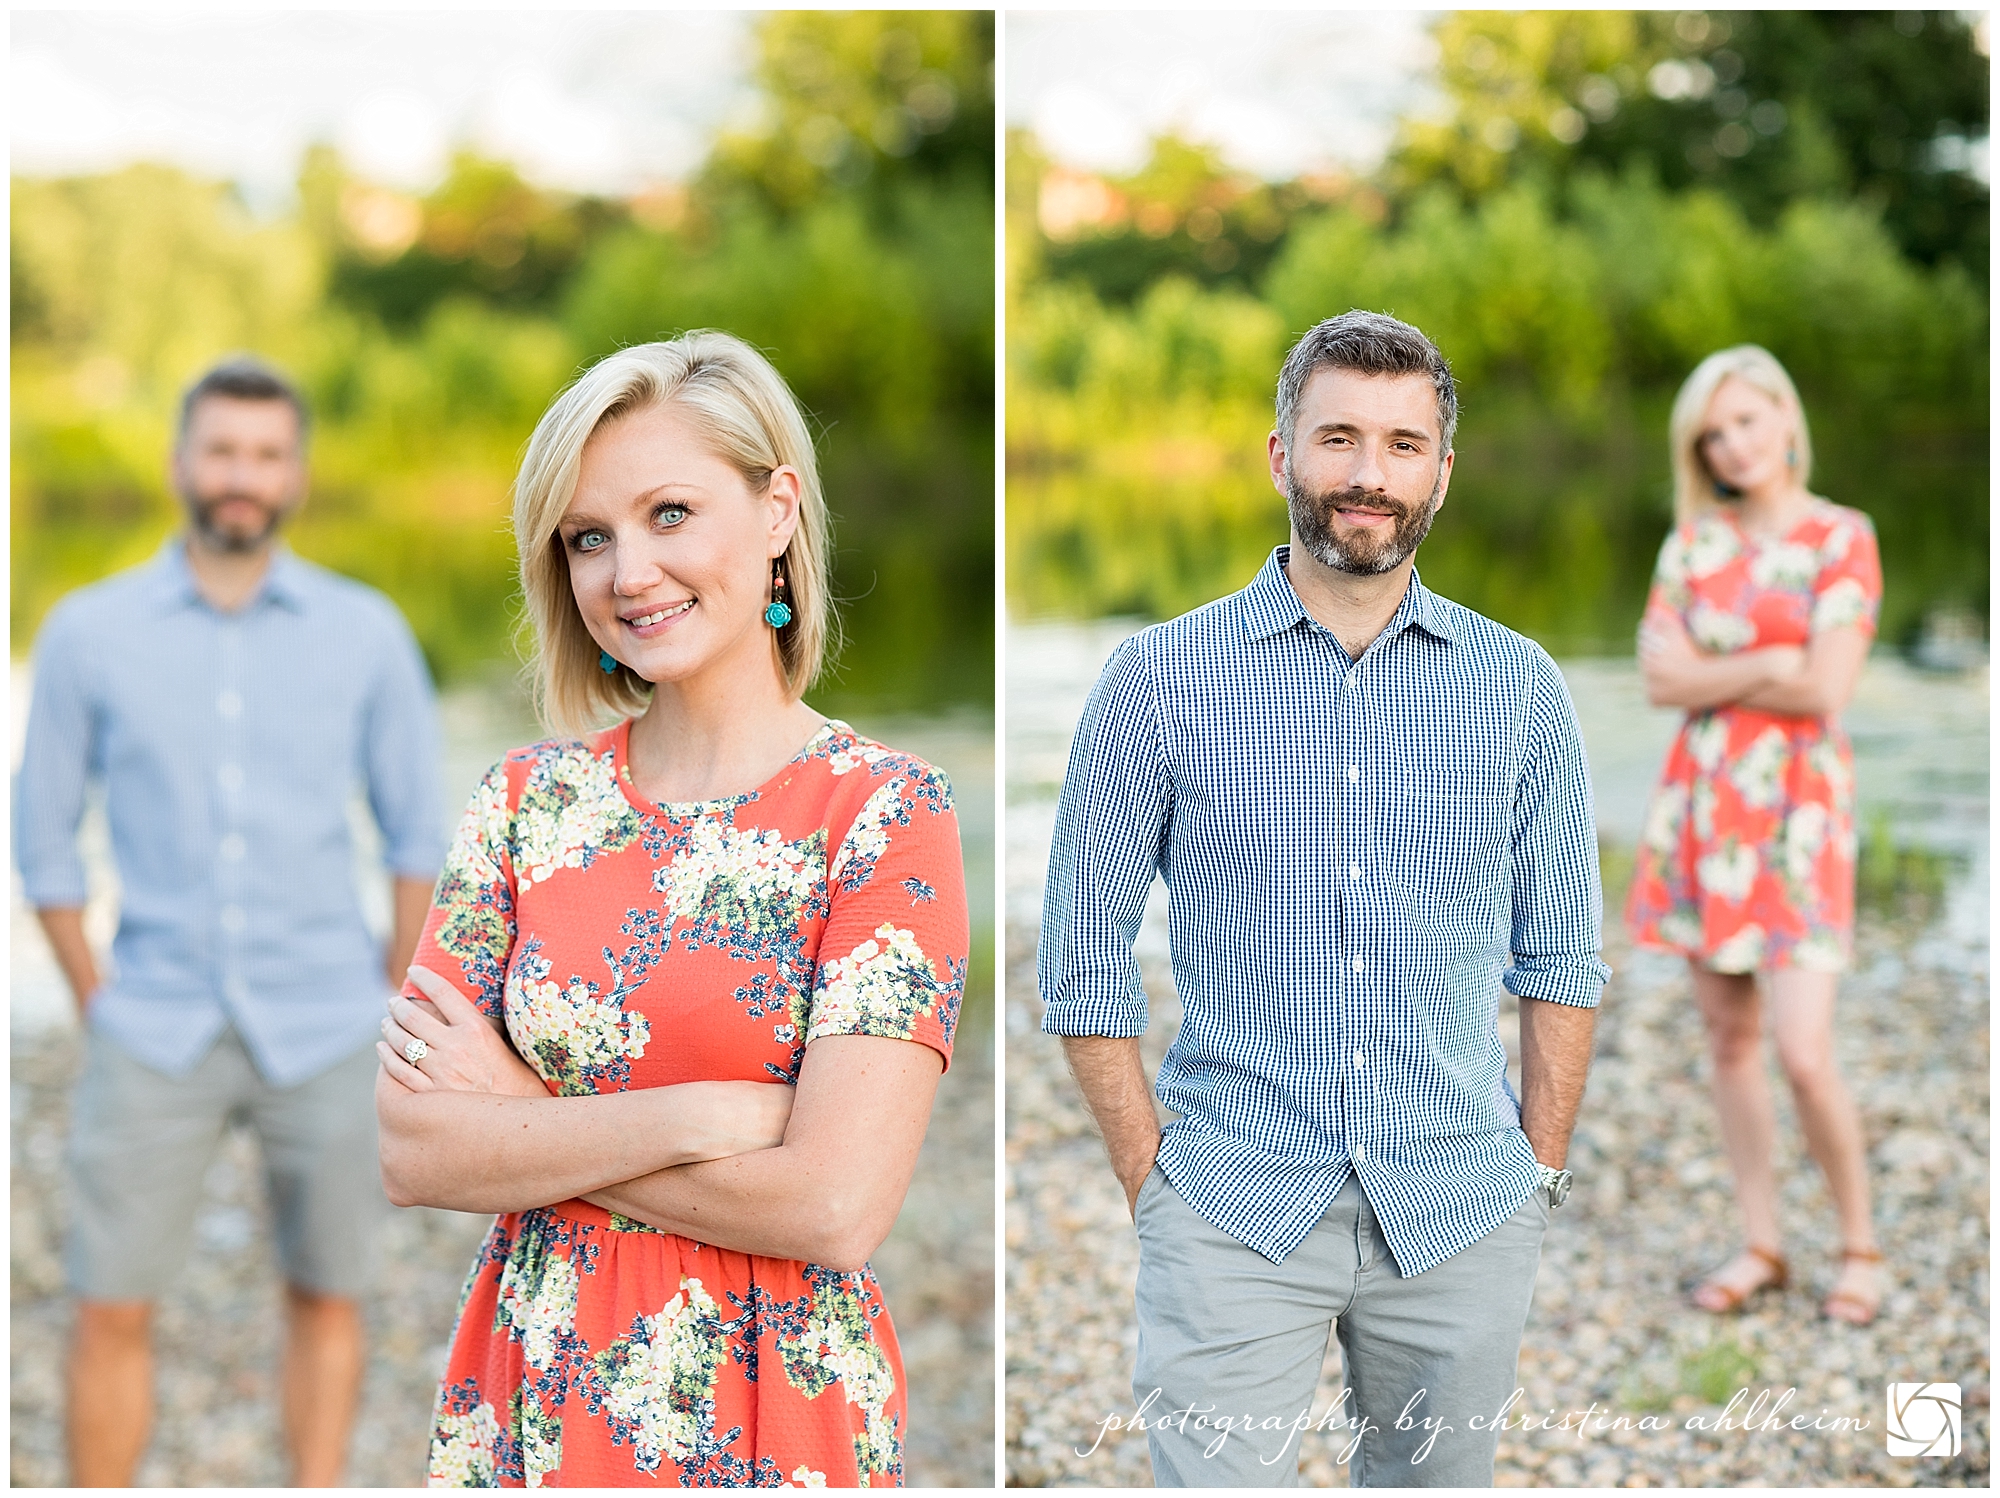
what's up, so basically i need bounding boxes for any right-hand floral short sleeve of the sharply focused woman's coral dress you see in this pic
[806,756,970,1066]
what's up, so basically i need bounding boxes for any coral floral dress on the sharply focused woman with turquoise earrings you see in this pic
[406,722,968,1488]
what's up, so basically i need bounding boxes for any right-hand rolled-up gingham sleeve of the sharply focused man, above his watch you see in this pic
[1502,650,1612,1008]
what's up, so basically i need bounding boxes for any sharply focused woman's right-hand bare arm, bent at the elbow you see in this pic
[586,1036,944,1270]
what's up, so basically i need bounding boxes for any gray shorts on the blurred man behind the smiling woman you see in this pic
[66,1030,388,1300]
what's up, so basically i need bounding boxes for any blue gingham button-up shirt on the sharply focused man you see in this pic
[1038,546,1610,1276]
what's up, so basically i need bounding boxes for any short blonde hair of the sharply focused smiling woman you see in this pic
[514,328,838,732]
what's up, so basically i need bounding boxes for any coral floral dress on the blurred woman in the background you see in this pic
[1626,500,1882,972]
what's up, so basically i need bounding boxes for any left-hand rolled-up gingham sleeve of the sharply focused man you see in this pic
[1036,640,1172,1036]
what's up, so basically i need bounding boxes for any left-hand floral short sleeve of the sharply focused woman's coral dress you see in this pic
[402,760,518,1020]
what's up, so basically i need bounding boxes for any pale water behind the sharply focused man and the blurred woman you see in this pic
[1006,620,1990,972]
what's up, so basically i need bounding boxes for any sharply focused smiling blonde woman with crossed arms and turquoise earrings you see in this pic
[378,332,966,1488]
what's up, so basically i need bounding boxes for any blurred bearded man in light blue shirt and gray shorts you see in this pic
[14,358,444,1486]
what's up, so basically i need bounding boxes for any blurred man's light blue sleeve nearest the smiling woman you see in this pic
[362,610,444,880]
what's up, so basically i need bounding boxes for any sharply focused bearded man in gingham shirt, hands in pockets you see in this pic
[1038,312,1610,1486]
